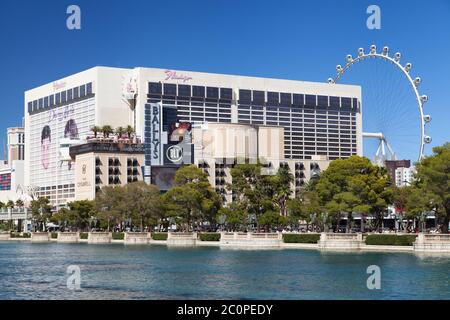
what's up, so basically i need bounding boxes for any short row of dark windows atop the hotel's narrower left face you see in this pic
[28,82,92,113]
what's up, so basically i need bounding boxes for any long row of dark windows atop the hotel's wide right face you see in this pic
[148,82,359,108]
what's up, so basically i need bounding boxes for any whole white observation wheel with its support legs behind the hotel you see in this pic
[328,45,431,166]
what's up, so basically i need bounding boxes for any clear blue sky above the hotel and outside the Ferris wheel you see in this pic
[0,0,450,158]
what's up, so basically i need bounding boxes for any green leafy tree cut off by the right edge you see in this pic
[408,142,450,233]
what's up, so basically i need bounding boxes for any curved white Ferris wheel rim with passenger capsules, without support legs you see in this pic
[328,45,431,161]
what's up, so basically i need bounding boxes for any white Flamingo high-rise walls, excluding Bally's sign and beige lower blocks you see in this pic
[24,67,362,206]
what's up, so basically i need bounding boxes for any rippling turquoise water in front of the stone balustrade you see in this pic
[0,242,450,300]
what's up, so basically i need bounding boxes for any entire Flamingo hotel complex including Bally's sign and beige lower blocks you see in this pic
[24,67,362,208]
